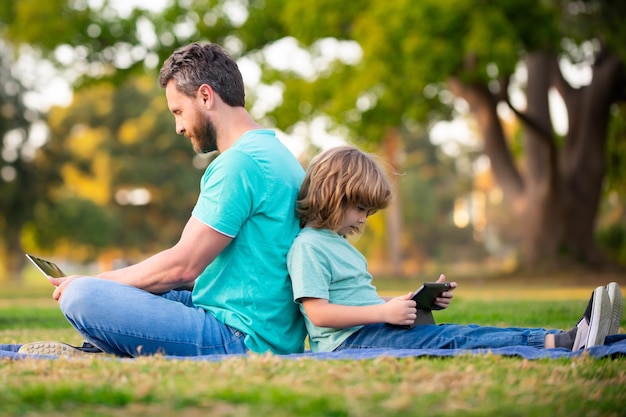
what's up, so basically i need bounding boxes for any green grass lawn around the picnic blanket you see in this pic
[0,278,626,417]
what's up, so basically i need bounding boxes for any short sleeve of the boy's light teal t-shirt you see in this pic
[287,238,332,303]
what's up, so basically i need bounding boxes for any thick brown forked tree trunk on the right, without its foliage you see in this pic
[448,49,622,269]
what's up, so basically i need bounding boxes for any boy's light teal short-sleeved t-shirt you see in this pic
[287,227,385,352]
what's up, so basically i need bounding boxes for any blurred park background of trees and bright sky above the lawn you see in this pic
[0,0,626,282]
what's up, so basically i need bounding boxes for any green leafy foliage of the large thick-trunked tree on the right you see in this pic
[264,0,626,268]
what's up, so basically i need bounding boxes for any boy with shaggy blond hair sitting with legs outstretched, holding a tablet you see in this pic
[287,146,622,352]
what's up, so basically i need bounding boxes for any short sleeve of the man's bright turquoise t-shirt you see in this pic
[192,150,260,237]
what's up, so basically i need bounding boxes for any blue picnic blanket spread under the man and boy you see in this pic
[0,334,626,362]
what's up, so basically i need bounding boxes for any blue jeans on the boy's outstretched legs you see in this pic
[335,323,560,351]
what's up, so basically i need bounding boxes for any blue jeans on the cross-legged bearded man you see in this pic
[61,277,248,357]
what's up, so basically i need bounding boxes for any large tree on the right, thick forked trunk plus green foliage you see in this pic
[254,0,626,267]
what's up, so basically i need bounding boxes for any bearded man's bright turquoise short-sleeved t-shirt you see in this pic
[192,130,306,354]
